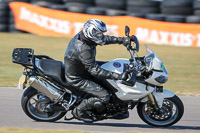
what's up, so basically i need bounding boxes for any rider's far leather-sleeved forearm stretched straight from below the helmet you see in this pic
[104,35,124,45]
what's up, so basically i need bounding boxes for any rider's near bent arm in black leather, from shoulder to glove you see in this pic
[79,49,120,80]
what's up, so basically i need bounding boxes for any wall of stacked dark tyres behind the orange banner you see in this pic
[0,0,200,33]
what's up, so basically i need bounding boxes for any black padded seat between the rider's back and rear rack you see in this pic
[39,59,65,83]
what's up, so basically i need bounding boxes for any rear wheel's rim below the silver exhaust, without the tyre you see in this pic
[27,93,62,121]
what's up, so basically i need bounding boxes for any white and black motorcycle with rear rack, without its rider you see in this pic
[12,26,184,127]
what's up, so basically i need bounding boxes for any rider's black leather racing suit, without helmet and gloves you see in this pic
[64,31,123,121]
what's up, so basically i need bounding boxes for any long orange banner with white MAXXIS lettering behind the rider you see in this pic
[10,2,200,47]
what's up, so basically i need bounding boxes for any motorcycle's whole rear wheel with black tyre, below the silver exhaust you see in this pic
[21,87,66,122]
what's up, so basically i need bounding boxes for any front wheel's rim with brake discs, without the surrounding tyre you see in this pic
[142,99,179,126]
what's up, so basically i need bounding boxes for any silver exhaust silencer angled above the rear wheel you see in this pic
[29,77,62,103]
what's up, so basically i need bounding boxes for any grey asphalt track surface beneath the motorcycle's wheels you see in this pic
[0,87,200,132]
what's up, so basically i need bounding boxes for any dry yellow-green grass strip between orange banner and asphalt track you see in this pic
[0,33,200,96]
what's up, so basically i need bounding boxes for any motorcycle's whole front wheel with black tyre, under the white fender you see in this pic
[137,95,184,127]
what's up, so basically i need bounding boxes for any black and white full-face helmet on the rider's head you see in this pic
[83,19,107,45]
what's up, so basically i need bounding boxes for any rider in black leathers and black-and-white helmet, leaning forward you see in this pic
[64,19,130,122]
